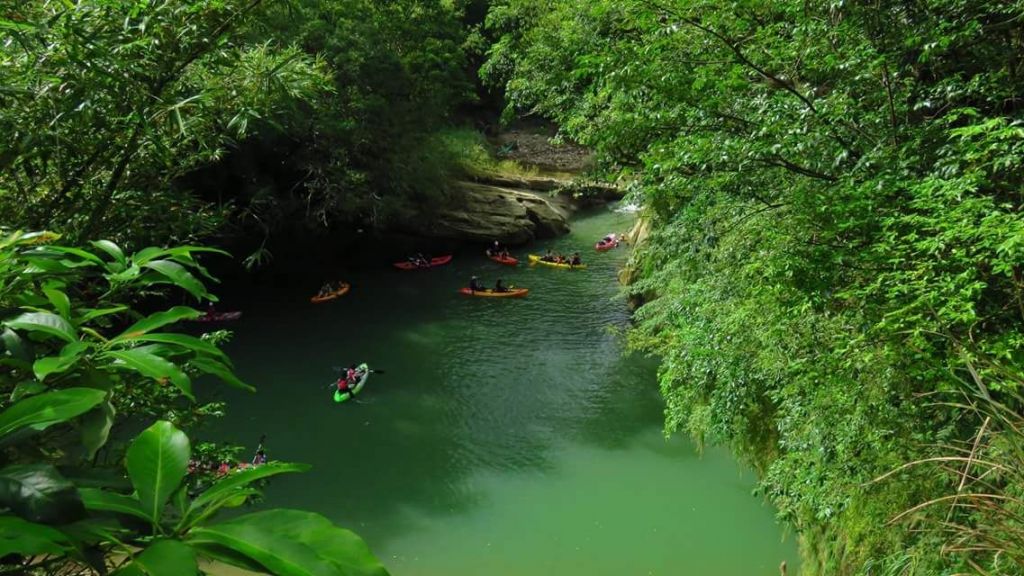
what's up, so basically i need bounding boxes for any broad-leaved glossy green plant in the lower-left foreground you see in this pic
[0,233,387,576]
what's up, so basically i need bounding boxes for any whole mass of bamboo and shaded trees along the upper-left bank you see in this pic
[0,0,479,251]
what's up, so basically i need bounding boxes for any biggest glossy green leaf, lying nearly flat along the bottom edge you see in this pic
[189,509,387,576]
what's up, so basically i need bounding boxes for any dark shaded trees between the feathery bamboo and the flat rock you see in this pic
[218,0,474,235]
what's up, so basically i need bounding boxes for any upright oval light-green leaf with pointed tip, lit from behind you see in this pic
[126,420,191,523]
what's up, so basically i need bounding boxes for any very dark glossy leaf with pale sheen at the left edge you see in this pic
[0,464,85,524]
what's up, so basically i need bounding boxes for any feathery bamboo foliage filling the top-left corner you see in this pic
[0,0,329,241]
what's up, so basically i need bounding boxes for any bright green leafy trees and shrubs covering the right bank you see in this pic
[483,0,1024,574]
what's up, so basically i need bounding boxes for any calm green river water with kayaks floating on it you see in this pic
[205,203,797,576]
